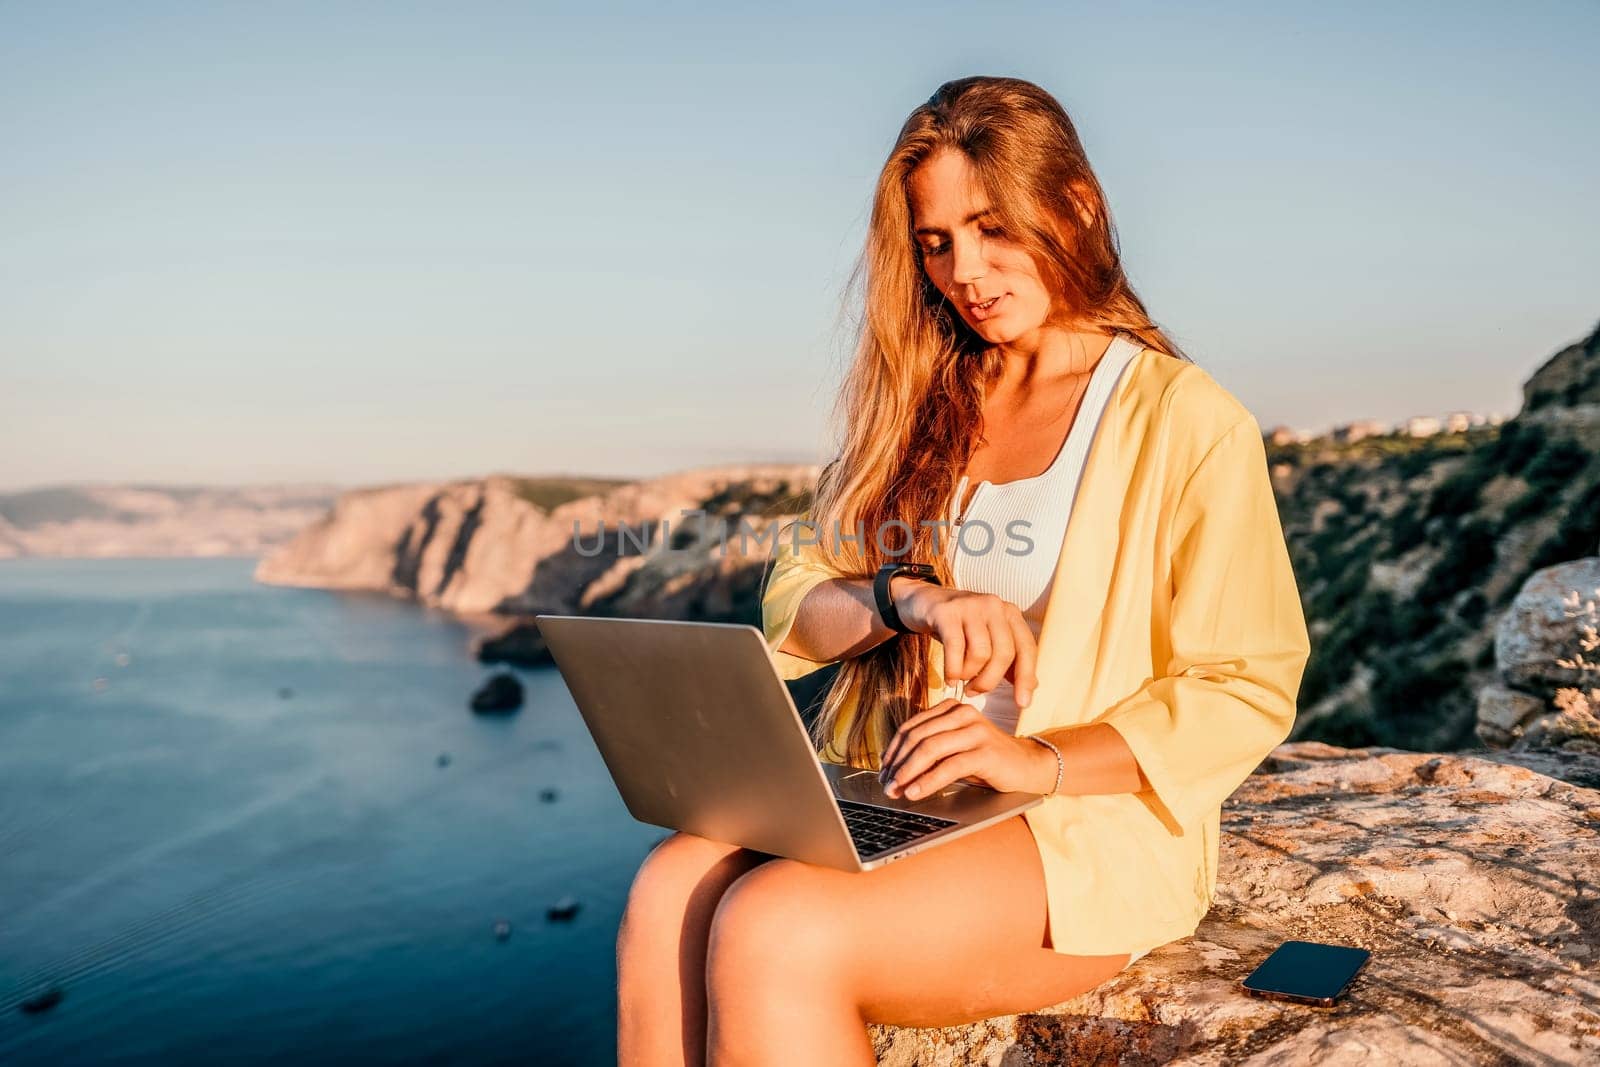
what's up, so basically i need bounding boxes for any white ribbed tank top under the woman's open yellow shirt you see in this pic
[944,333,1142,733]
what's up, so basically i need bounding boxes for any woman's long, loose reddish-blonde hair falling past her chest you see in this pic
[810,77,1189,766]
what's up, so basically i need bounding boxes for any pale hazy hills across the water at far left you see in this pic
[0,485,339,558]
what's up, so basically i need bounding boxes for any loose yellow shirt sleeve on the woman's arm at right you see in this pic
[1098,416,1310,833]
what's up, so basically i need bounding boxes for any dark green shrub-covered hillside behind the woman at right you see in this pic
[1269,323,1600,749]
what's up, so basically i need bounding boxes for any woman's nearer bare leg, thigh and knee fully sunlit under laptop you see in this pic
[706,816,1128,1067]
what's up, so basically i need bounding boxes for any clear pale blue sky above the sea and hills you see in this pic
[0,0,1600,488]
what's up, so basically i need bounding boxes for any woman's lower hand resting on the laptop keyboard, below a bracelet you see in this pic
[878,697,1056,800]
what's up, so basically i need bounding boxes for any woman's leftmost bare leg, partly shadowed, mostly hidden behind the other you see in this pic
[616,833,771,1067]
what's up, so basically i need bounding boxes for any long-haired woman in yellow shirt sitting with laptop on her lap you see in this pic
[618,78,1309,1065]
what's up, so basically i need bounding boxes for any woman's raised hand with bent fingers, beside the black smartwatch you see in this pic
[890,577,1038,707]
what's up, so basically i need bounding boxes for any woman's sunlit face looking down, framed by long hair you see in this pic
[907,149,1050,344]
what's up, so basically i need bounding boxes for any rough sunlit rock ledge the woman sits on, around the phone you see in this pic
[872,742,1600,1067]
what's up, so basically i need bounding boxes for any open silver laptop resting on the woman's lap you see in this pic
[534,614,1043,870]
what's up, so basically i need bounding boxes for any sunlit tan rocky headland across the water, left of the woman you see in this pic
[256,466,818,621]
